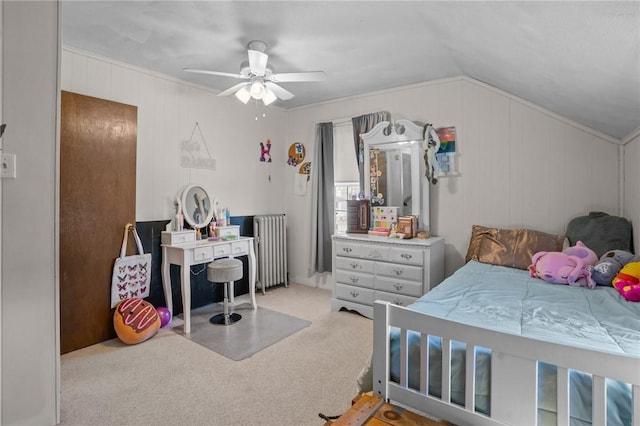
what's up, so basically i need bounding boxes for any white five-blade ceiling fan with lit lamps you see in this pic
[183,40,327,105]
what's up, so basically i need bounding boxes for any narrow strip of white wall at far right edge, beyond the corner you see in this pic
[622,129,640,253]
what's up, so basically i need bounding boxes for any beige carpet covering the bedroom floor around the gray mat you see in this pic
[61,284,373,426]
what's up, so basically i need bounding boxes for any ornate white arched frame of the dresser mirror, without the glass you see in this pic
[360,120,429,229]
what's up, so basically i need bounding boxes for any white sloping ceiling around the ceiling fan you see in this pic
[62,1,640,139]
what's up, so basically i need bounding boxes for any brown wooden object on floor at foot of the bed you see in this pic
[324,394,454,426]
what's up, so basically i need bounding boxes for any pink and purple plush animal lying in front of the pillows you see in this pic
[529,246,596,288]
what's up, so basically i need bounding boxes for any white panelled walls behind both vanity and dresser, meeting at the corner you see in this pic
[62,49,621,288]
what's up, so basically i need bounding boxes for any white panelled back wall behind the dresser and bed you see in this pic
[285,78,620,282]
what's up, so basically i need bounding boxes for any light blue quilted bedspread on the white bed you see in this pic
[391,261,640,424]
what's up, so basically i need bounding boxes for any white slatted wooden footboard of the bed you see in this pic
[373,301,640,426]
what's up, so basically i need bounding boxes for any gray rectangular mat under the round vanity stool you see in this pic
[172,304,311,361]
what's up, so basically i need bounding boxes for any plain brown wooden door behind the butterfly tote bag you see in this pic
[60,91,137,353]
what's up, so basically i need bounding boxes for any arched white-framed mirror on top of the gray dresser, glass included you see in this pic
[362,120,429,228]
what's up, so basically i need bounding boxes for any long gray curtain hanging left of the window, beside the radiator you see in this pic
[310,123,335,273]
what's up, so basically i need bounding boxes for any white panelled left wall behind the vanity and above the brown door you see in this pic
[61,48,290,221]
